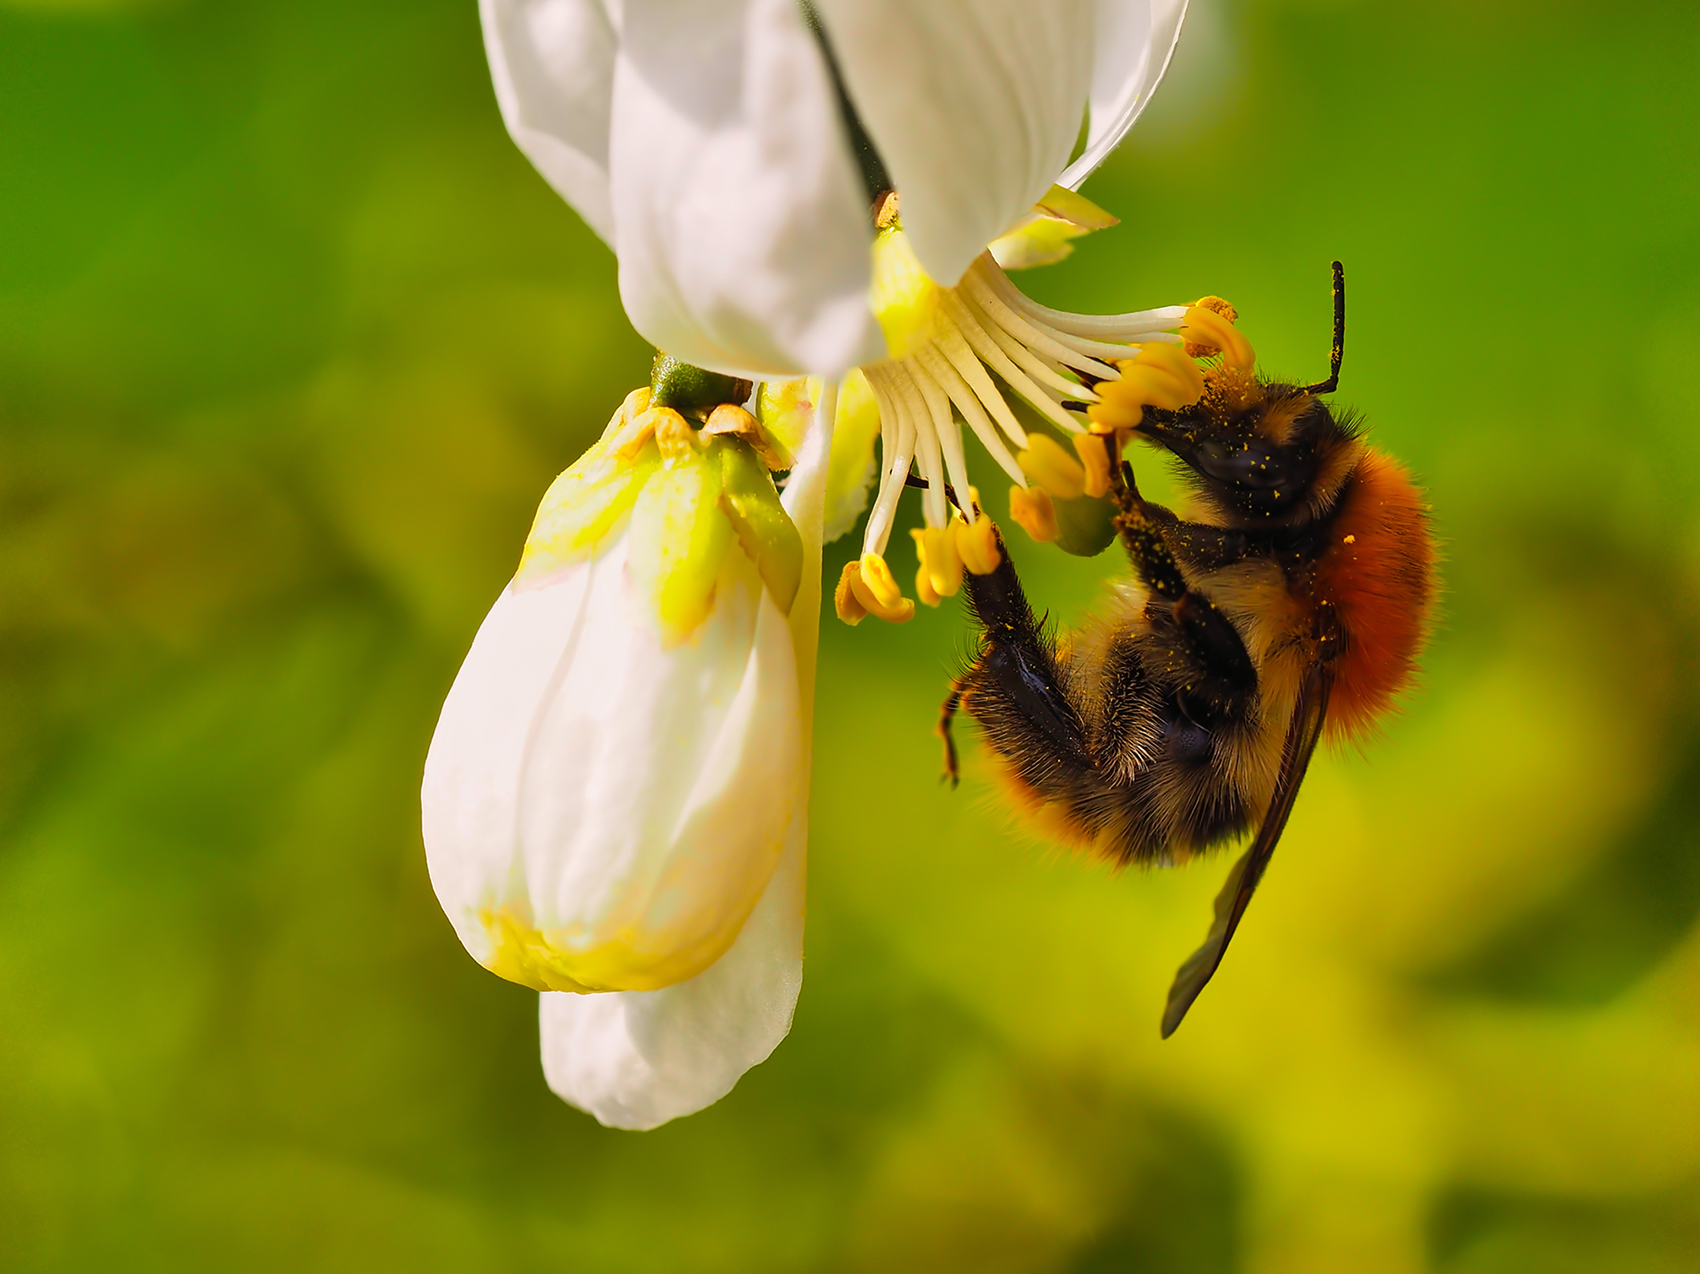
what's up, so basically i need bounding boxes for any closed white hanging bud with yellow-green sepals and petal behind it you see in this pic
[422,386,828,1128]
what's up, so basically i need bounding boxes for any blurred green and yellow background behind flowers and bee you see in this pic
[0,0,1700,1274]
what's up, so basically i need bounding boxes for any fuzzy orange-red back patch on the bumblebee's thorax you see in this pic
[1312,451,1435,738]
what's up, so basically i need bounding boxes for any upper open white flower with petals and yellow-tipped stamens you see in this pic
[481,0,1205,623]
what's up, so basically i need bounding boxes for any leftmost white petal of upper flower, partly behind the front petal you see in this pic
[478,0,621,243]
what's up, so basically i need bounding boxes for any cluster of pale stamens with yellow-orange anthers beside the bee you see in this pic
[835,226,1253,624]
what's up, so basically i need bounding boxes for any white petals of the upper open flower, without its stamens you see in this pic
[479,0,1185,378]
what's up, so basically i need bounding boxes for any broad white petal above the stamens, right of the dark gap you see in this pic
[816,0,1097,286]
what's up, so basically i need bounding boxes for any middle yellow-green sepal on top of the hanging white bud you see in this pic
[626,447,733,646]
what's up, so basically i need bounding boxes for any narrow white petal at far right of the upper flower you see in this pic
[1057,0,1187,191]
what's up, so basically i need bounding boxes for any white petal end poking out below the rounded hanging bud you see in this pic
[539,810,808,1129]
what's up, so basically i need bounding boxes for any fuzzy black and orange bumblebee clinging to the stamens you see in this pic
[938,262,1435,1038]
